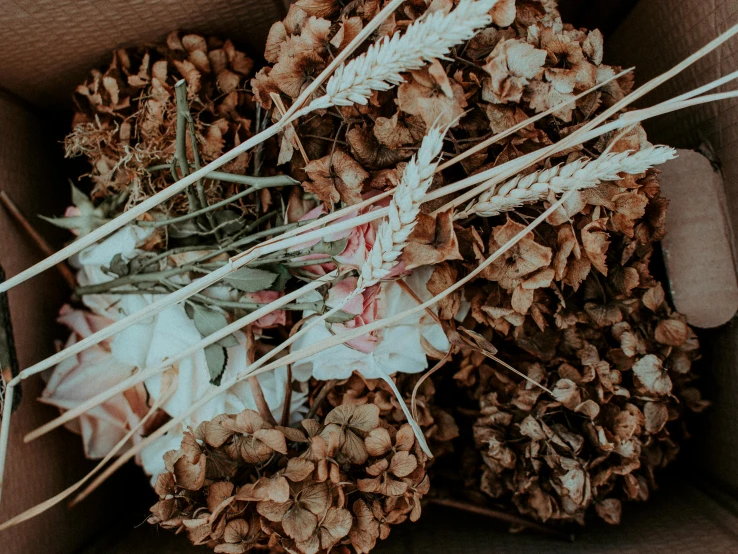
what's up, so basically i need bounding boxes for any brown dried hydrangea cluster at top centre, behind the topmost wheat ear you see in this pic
[252,0,631,194]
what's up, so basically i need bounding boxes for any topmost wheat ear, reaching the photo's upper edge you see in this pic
[309,0,498,109]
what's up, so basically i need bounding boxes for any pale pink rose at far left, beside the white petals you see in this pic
[40,306,151,459]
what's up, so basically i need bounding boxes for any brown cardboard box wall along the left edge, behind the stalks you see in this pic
[0,95,118,554]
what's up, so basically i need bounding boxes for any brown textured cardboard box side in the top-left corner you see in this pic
[0,0,285,108]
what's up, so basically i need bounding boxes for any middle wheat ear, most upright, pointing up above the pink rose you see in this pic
[356,127,445,290]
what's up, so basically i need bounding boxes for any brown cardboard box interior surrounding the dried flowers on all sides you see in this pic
[0,0,738,554]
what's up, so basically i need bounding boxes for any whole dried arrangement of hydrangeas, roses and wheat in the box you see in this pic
[0,0,738,554]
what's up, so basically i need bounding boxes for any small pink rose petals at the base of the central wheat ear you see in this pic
[326,277,379,354]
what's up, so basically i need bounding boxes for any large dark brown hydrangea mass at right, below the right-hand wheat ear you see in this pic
[442,155,706,523]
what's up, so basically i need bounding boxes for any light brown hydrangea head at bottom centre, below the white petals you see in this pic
[149,404,429,554]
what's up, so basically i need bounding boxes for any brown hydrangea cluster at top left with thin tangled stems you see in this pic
[65,32,255,212]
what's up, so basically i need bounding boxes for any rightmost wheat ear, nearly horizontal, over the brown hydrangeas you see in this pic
[457,146,676,218]
